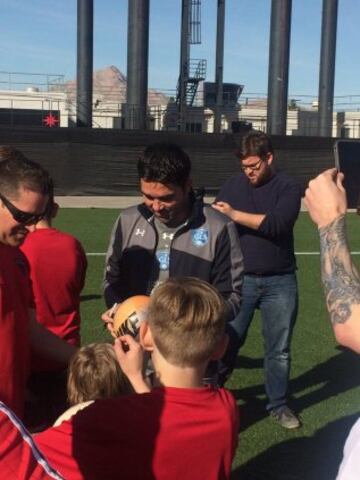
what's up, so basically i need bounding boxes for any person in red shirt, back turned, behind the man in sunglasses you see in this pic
[20,191,87,431]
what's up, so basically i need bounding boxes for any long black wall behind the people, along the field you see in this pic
[0,127,336,196]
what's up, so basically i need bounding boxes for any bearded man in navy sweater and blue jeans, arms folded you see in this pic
[213,132,301,429]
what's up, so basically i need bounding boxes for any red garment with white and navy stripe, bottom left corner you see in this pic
[0,402,62,480]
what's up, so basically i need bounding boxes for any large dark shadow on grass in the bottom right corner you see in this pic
[231,414,358,480]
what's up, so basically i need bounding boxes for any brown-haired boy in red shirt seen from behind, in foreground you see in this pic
[35,277,238,480]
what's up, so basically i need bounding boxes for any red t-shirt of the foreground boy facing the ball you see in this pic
[35,387,238,480]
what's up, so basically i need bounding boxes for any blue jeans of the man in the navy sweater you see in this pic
[221,273,298,410]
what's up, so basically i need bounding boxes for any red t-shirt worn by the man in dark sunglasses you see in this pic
[0,243,33,417]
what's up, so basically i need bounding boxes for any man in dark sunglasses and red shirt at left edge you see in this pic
[0,148,75,416]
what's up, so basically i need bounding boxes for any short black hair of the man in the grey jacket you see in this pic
[137,143,191,187]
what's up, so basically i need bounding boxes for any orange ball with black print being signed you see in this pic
[114,295,150,338]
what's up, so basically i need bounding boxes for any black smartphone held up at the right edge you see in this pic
[334,140,360,208]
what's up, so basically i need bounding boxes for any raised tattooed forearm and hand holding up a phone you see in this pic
[305,169,360,353]
